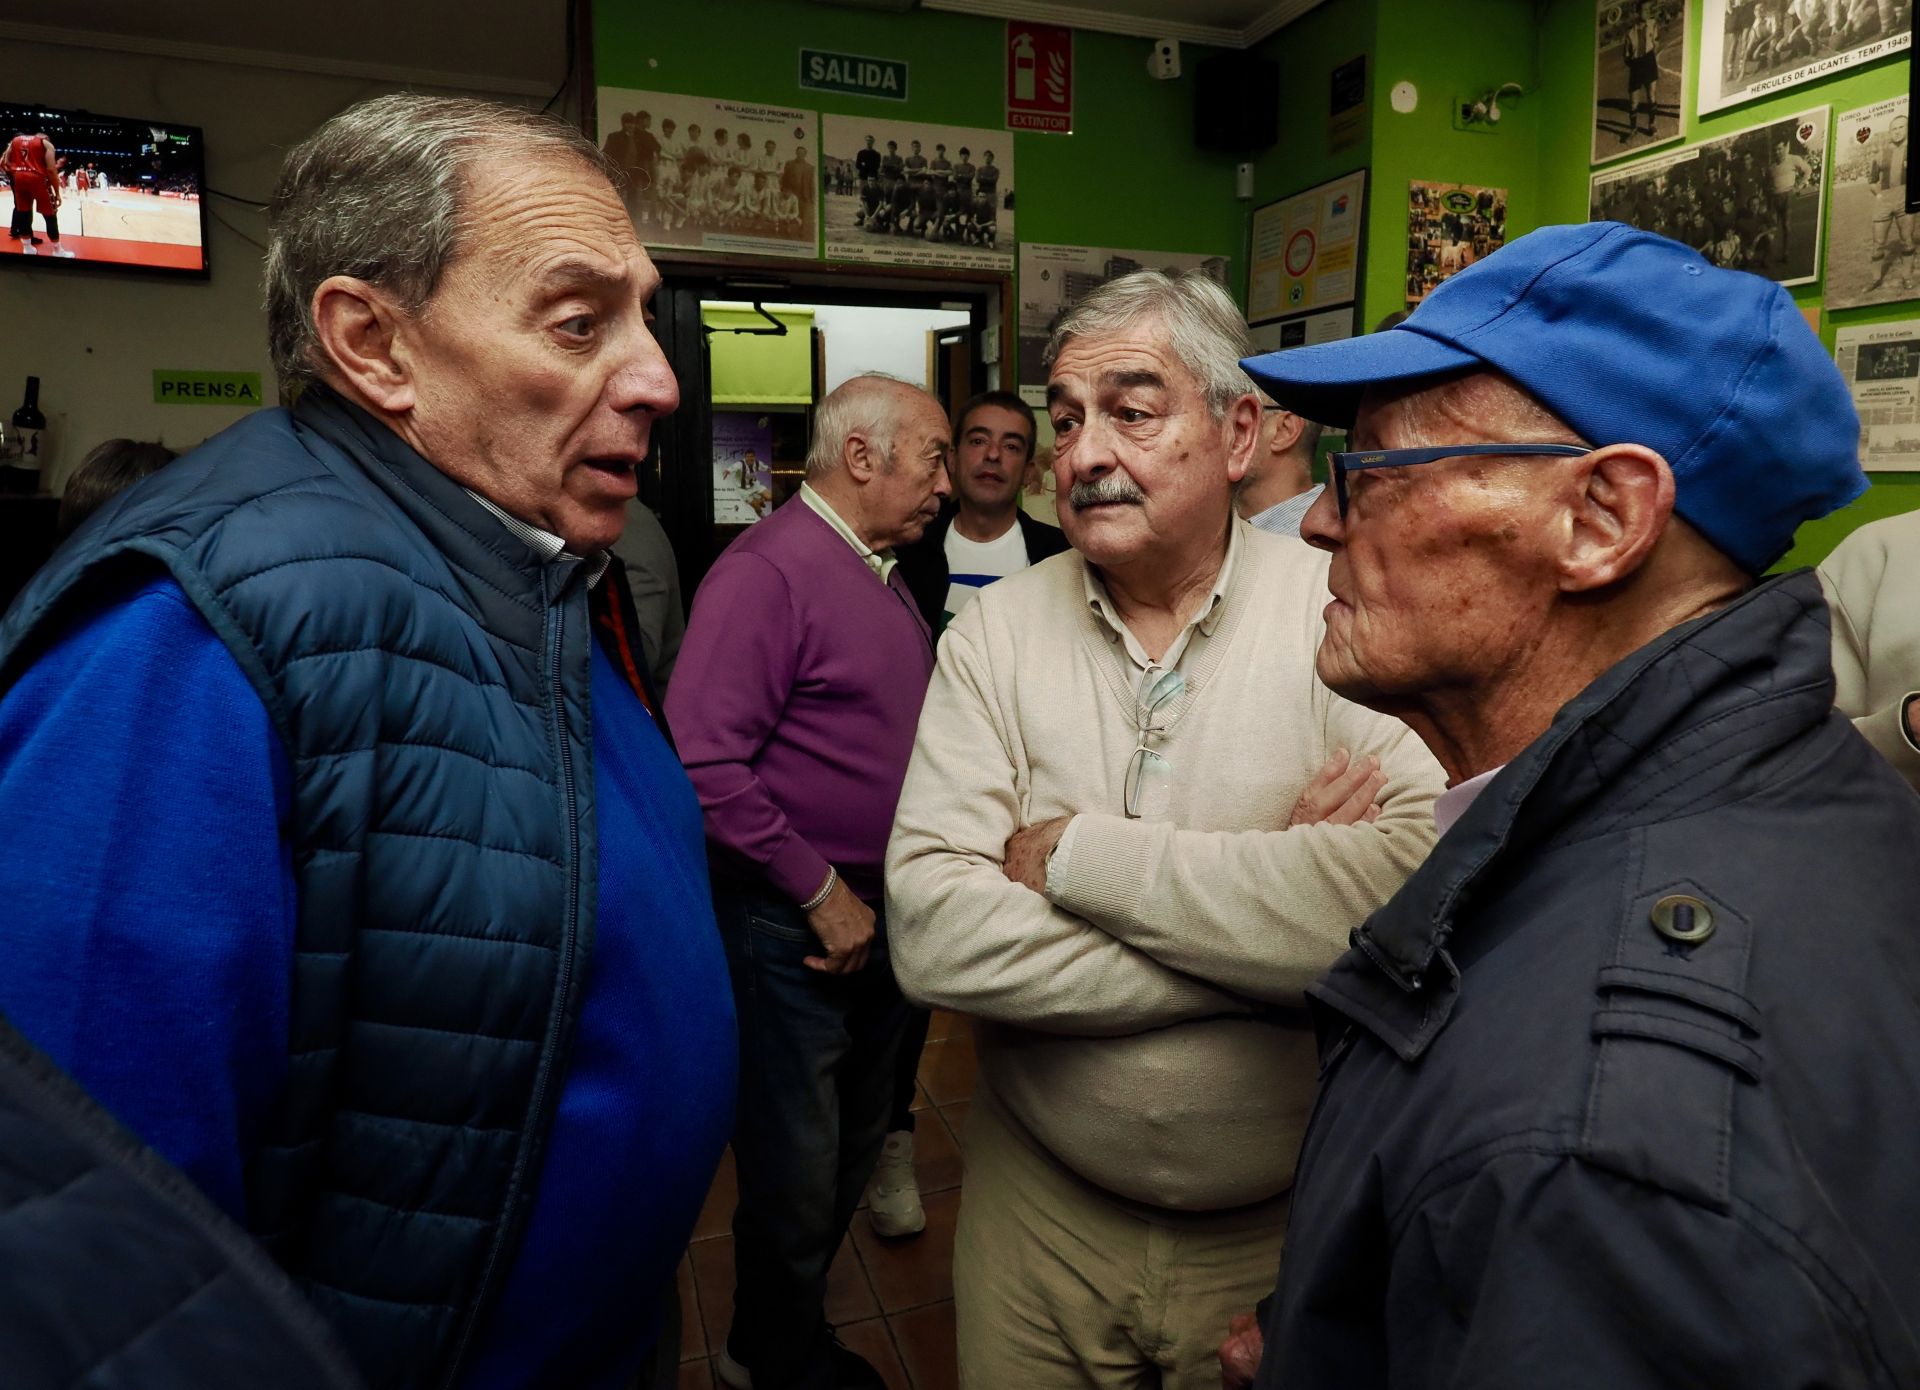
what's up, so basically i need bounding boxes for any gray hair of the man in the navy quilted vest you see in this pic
[265,92,620,388]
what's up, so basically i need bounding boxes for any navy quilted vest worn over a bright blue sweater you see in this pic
[0,388,612,1386]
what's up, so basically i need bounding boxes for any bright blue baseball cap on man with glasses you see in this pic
[1240,223,1866,574]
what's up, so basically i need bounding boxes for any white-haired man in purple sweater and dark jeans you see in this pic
[668,376,950,1390]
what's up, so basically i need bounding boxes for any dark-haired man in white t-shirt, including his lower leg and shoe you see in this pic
[868,392,1068,1236]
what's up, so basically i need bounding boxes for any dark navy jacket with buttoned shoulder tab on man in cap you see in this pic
[1258,570,1920,1390]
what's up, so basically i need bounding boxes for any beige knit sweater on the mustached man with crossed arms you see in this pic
[887,522,1444,1211]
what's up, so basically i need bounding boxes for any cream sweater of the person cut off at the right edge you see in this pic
[1820,511,1920,789]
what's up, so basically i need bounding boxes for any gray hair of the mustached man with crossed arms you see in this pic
[1044,271,1254,420]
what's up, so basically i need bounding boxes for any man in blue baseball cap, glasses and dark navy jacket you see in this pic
[1221,223,1920,1390]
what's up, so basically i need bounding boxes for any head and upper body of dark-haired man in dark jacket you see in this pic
[899,392,1068,634]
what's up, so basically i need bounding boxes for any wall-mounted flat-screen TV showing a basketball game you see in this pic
[0,102,207,278]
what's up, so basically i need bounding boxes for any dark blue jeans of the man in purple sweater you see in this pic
[714,875,910,1390]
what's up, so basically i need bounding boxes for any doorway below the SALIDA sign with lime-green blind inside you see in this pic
[639,261,1012,607]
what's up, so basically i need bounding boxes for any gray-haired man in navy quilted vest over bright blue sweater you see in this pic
[0,96,735,1390]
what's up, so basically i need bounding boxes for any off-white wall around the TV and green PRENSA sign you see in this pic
[0,38,538,491]
